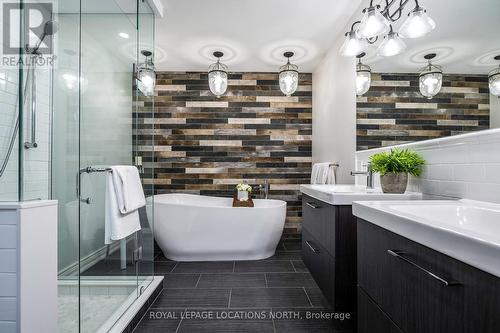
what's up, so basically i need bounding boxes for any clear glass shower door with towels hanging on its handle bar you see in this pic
[80,0,138,332]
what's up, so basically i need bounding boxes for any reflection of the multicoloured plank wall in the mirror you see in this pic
[357,73,490,150]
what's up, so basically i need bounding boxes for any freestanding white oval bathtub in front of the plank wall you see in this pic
[150,194,286,261]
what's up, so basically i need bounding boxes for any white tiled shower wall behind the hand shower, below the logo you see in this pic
[0,68,51,201]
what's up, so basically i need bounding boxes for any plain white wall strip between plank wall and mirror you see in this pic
[312,38,356,184]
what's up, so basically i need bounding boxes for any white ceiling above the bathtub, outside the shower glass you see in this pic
[155,0,361,72]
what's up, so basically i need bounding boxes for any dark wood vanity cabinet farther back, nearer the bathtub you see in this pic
[302,195,357,313]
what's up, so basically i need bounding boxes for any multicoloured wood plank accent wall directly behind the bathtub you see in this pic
[135,72,312,232]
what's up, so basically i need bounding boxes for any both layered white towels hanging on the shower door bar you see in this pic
[104,166,146,244]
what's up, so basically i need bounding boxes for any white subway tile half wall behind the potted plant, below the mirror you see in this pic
[356,129,500,203]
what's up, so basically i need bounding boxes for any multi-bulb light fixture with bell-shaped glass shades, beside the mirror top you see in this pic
[340,0,436,57]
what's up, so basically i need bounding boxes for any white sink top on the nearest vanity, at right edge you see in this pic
[353,200,500,277]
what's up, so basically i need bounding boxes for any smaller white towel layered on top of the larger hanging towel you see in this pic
[111,165,146,214]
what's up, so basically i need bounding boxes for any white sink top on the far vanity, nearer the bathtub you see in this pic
[300,184,422,205]
